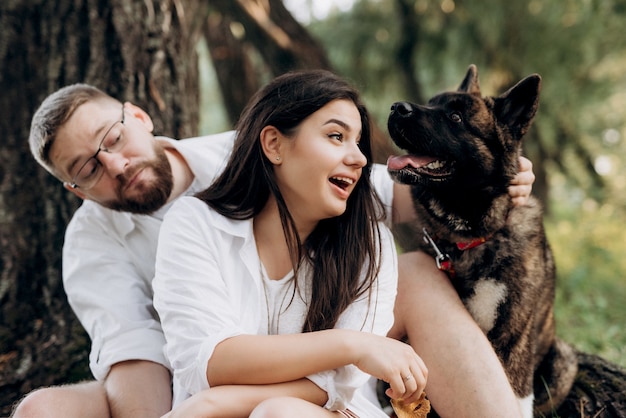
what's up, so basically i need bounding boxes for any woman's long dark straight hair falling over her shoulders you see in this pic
[197,70,384,332]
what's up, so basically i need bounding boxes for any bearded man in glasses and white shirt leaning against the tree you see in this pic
[14,84,534,418]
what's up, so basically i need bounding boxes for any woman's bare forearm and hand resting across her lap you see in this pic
[207,329,427,398]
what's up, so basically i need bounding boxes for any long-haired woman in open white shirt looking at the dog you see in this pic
[154,71,427,417]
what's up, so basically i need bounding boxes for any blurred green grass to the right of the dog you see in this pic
[545,205,626,367]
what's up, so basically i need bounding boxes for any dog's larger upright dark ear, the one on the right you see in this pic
[494,74,541,138]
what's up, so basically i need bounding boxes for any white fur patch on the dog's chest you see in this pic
[466,279,507,333]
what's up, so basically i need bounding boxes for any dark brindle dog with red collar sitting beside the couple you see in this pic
[388,65,577,417]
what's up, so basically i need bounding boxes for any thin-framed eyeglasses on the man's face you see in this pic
[69,105,126,190]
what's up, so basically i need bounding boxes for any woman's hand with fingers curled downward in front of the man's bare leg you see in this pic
[354,332,428,403]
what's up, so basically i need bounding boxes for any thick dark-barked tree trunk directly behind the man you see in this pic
[0,0,204,416]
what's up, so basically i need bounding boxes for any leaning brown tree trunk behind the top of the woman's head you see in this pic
[205,0,394,163]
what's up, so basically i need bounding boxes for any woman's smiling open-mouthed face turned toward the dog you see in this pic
[275,100,367,224]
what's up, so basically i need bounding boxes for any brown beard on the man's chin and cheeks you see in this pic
[104,144,174,215]
